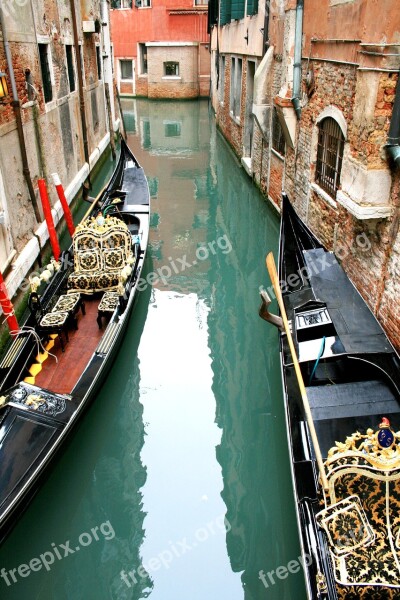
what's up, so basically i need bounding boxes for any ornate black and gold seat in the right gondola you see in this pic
[317,434,400,598]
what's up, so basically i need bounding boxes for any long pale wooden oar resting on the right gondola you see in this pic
[266,252,328,490]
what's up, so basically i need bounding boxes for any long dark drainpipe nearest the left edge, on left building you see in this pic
[0,4,42,223]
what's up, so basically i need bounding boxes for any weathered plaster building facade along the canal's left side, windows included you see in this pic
[0,0,118,296]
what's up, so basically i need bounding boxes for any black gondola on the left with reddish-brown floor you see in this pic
[0,140,150,541]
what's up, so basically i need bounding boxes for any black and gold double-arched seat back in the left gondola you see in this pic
[68,217,133,294]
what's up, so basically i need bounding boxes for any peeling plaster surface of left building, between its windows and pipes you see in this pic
[0,0,110,300]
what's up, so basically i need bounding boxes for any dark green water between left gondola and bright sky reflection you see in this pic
[0,278,151,600]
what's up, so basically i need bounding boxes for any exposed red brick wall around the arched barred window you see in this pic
[285,62,400,348]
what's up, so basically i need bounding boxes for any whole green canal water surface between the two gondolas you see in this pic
[0,100,305,600]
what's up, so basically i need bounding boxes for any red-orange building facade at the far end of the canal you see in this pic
[111,0,210,98]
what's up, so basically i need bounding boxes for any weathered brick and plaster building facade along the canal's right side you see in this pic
[210,0,400,348]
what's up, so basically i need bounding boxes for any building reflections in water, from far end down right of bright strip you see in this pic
[126,100,302,600]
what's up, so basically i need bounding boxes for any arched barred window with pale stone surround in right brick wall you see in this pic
[315,117,344,196]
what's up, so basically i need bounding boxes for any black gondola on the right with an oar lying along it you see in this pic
[260,194,400,600]
